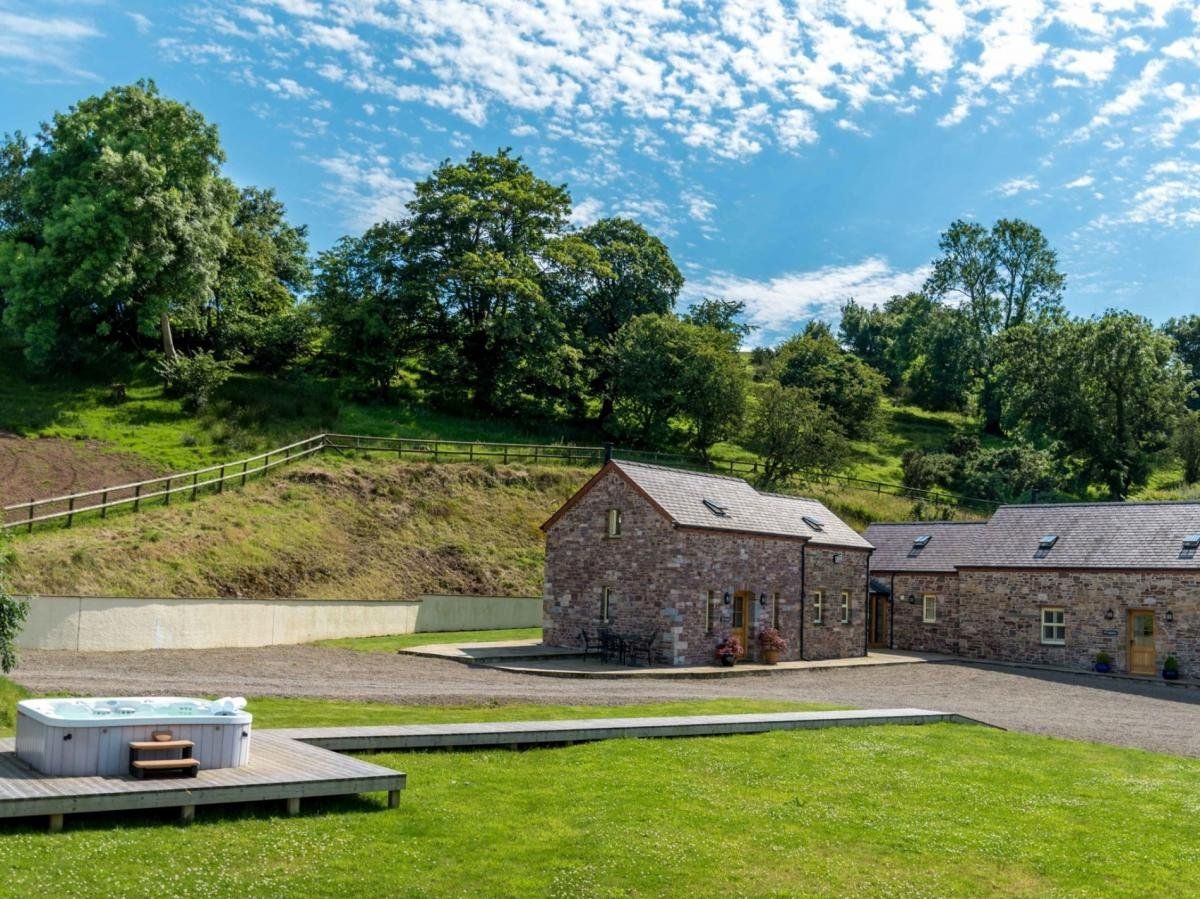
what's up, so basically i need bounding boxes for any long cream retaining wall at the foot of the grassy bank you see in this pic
[10,595,541,652]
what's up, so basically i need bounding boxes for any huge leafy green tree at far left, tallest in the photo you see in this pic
[0,82,236,367]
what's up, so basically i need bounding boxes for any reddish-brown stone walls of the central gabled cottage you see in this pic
[542,472,866,665]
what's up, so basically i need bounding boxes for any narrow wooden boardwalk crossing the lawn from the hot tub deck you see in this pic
[267,708,976,753]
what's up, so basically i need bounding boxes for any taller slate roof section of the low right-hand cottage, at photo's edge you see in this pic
[961,502,1200,569]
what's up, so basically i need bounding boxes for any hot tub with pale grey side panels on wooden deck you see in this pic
[17,696,251,777]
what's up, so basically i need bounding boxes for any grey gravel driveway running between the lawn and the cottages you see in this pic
[13,646,1200,756]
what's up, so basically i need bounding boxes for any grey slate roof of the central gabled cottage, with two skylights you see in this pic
[613,461,871,550]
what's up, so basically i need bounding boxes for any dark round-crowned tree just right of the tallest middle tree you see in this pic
[576,218,683,424]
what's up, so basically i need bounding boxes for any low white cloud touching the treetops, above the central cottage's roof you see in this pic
[688,256,929,336]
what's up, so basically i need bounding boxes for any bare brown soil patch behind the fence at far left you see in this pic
[0,432,162,511]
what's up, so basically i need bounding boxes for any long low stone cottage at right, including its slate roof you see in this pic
[865,502,1200,675]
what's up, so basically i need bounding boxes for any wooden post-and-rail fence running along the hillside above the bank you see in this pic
[0,433,1000,532]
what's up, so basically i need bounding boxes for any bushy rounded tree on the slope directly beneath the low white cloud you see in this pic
[774,320,884,438]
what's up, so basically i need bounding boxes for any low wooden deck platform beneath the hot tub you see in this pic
[0,730,404,829]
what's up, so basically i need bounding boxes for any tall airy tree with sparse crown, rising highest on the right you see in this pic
[925,218,1066,432]
